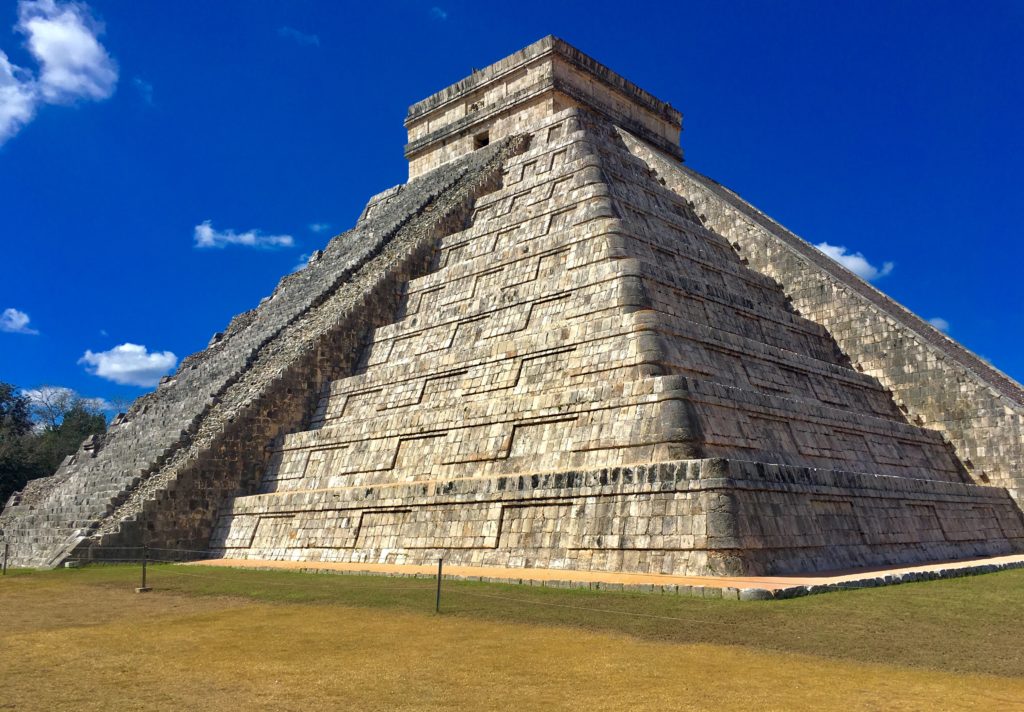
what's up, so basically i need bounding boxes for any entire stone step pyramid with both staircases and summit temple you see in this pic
[0,37,1024,576]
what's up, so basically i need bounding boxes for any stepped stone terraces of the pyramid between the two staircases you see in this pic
[211,110,1024,575]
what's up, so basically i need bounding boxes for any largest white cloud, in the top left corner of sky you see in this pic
[0,0,118,145]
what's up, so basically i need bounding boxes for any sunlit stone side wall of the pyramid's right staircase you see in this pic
[622,131,1024,502]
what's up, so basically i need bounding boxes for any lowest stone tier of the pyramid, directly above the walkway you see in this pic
[210,458,1024,577]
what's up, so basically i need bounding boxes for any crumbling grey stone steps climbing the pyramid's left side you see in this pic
[0,141,528,567]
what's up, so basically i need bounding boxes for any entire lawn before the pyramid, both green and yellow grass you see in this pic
[0,566,1024,710]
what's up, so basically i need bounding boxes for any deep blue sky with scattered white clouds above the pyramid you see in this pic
[0,0,1024,411]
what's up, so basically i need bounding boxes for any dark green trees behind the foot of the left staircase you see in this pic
[0,382,106,507]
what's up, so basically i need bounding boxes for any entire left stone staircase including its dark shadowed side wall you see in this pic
[0,137,524,567]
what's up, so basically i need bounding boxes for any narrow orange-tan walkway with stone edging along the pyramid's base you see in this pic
[188,554,1024,599]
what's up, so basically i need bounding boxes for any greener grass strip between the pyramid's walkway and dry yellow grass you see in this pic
[8,564,1024,677]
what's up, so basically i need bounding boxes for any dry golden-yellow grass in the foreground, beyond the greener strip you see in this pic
[0,576,1024,711]
